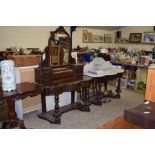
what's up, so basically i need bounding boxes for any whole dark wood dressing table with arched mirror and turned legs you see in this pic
[35,27,91,124]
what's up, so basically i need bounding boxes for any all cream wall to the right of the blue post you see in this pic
[73,26,154,51]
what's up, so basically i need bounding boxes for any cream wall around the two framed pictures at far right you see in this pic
[113,26,154,51]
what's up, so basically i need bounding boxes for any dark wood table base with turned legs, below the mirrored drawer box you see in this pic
[38,75,91,124]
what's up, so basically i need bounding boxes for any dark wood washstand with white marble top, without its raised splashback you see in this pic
[84,66,124,105]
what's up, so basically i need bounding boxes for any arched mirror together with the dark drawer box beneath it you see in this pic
[35,26,83,86]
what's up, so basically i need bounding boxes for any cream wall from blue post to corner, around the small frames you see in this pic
[72,27,114,48]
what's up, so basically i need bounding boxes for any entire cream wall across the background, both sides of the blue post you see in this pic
[0,26,154,51]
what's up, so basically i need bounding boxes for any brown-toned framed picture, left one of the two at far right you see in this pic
[129,33,142,43]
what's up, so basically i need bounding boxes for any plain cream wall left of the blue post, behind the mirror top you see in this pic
[0,26,69,51]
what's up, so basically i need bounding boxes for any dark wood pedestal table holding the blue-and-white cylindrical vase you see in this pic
[0,82,42,129]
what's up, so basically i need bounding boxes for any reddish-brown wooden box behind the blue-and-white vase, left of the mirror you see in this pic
[8,55,41,67]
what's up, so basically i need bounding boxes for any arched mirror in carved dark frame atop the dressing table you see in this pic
[41,26,71,67]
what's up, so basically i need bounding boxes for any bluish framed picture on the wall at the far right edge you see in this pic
[142,32,155,43]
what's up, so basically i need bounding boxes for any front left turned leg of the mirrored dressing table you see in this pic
[53,94,61,124]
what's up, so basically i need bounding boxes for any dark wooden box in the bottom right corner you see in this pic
[124,102,155,129]
